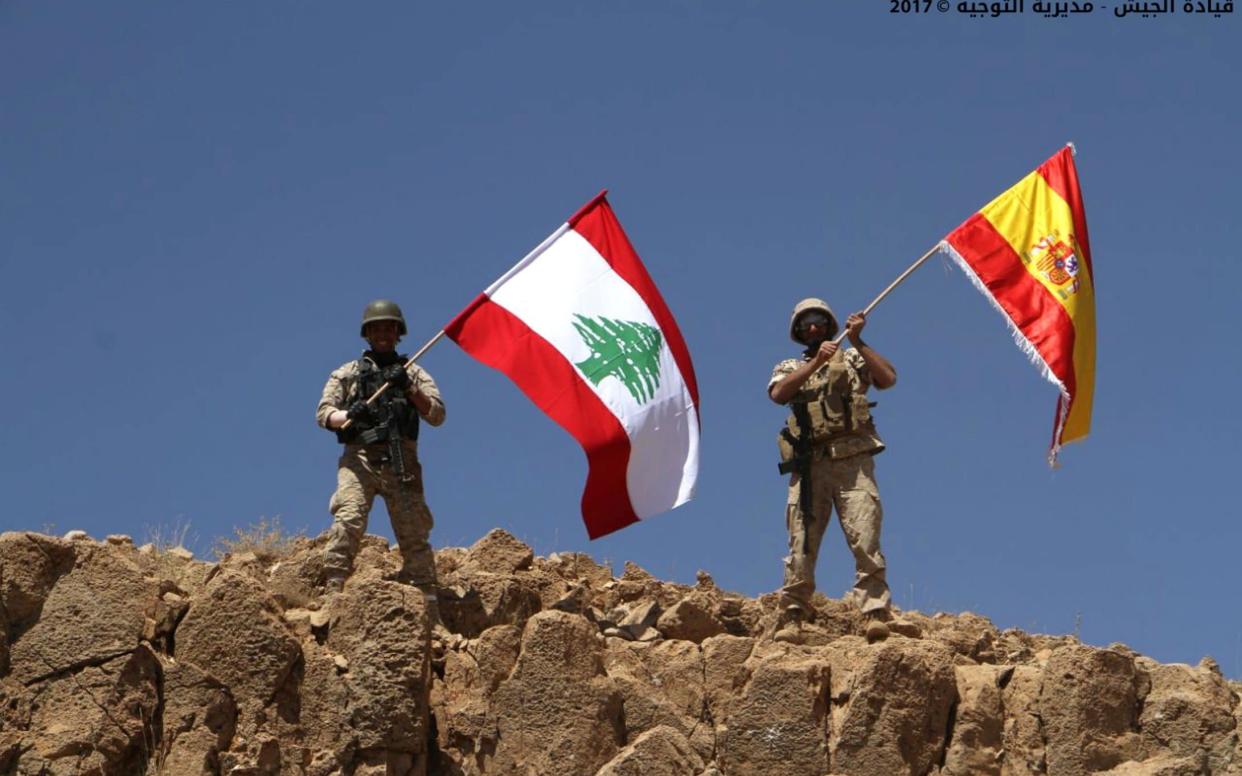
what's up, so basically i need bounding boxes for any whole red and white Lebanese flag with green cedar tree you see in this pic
[445,191,699,539]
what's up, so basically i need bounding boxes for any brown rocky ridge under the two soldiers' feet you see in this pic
[0,530,1242,776]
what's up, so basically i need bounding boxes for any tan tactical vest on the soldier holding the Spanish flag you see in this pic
[776,350,884,473]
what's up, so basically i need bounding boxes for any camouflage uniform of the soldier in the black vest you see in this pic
[315,356,445,585]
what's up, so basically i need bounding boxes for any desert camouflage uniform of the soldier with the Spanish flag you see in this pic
[768,348,891,612]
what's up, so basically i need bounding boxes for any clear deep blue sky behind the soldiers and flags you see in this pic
[0,0,1242,678]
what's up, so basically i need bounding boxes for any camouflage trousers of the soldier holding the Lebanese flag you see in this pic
[323,441,436,585]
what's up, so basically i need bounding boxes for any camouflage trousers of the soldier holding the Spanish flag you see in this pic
[781,454,892,612]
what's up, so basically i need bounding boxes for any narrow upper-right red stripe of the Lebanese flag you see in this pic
[570,201,699,416]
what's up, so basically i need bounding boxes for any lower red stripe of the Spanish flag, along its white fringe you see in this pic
[945,212,1076,404]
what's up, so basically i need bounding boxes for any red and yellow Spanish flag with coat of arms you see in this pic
[940,147,1095,466]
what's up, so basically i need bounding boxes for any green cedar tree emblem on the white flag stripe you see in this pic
[574,314,664,405]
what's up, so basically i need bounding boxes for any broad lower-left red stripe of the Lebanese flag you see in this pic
[445,294,638,539]
